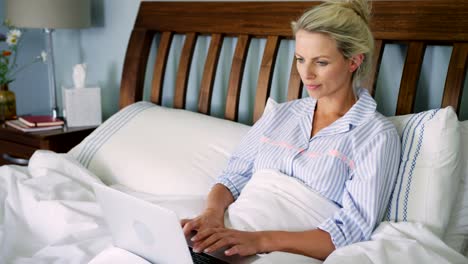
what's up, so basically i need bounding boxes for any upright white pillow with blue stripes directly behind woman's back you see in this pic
[386,107,461,238]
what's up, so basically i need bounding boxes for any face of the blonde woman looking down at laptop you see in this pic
[295,30,359,101]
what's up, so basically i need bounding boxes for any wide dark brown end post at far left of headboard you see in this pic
[119,29,154,108]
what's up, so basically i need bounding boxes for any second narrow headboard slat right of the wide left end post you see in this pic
[174,32,197,108]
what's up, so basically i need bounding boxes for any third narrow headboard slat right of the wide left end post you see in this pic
[198,34,223,114]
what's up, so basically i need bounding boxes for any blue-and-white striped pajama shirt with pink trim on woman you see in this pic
[217,88,401,248]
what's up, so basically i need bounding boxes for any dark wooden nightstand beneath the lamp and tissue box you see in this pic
[0,124,96,165]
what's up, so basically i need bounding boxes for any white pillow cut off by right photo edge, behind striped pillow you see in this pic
[444,120,468,253]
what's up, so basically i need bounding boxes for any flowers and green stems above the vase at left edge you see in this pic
[0,21,47,86]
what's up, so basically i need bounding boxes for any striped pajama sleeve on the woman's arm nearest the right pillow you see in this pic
[317,129,400,248]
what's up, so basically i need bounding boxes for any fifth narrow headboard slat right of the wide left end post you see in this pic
[253,36,280,123]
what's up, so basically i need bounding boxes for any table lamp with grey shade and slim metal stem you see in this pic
[5,0,91,117]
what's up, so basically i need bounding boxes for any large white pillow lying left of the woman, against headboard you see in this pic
[70,102,249,195]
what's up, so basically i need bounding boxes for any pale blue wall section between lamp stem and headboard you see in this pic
[54,0,140,118]
